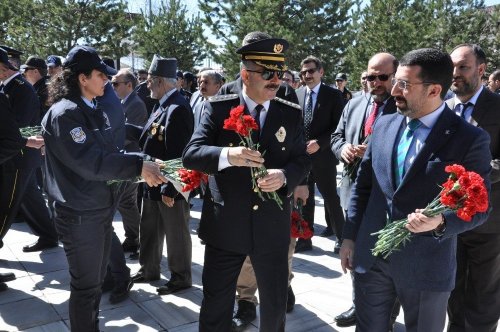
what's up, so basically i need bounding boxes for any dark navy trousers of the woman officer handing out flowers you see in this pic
[55,207,113,332]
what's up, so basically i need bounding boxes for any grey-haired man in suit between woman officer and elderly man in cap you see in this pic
[111,69,148,253]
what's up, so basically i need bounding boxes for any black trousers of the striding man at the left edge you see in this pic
[0,166,57,247]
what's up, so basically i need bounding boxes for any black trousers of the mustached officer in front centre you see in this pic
[199,245,288,332]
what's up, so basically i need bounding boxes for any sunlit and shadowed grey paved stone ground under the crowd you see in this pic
[0,191,494,332]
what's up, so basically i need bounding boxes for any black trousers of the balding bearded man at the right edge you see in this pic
[448,231,500,332]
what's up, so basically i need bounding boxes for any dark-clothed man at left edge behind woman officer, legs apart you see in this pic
[0,49,58,252]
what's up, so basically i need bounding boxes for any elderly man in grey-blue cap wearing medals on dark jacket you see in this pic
[132,55,194,295]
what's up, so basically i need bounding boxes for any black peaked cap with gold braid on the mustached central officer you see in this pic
[236,38,288,71]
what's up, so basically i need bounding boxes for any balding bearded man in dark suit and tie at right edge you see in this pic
[446,44,500,332]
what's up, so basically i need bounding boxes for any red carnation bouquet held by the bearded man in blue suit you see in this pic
[372,164,488,258]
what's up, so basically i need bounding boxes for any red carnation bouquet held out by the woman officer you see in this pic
[107,158,208,201]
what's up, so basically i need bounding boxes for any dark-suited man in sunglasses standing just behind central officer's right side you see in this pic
[295,56,344,253]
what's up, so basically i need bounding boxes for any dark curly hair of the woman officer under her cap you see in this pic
[48,69,92,105]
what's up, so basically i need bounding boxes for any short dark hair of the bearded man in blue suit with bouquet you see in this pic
[399,48,453,99]
